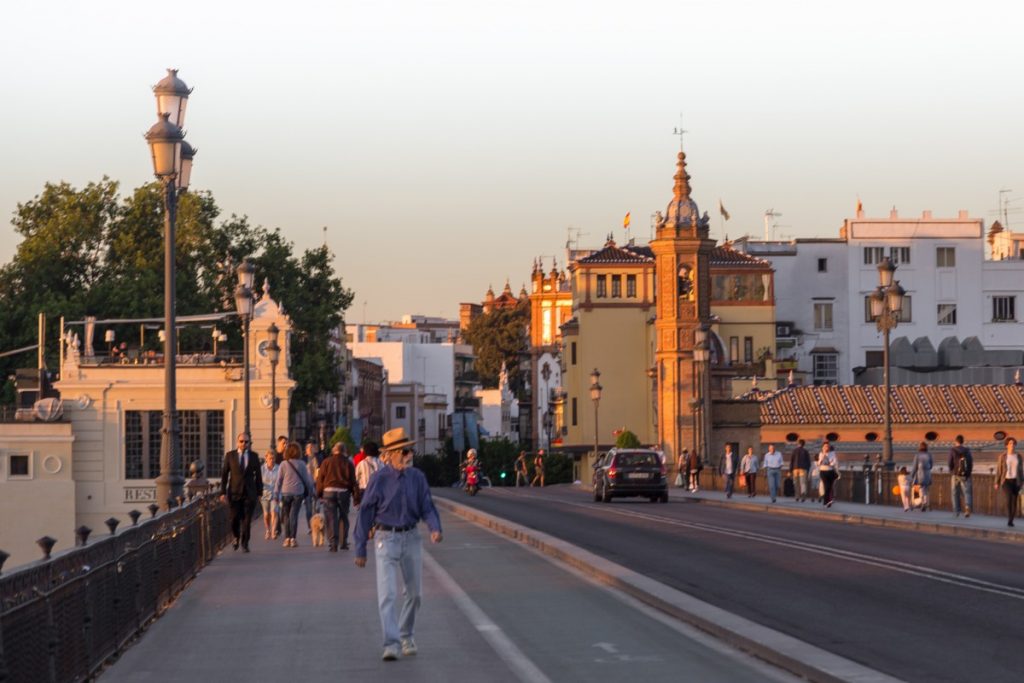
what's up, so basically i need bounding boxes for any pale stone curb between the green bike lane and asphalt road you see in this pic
[434,497,900,683]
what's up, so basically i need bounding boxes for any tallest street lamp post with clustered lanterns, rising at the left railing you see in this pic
[145,69,196,510]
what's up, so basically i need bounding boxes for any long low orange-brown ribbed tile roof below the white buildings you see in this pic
[752,384,1024,425]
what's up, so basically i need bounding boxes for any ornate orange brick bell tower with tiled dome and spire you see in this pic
[650,152,715,463]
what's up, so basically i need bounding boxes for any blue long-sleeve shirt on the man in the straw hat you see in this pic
[355,465,441,557]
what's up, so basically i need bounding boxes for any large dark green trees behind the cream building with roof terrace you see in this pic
[0,177,353,412]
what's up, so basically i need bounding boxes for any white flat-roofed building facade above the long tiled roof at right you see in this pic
[735,210,1024,384]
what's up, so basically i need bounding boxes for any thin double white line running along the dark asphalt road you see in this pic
[499,494,1024,600]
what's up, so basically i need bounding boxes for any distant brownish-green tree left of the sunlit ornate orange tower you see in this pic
[463,301,529,393]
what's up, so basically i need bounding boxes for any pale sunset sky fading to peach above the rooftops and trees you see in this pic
[0,0,1024,323]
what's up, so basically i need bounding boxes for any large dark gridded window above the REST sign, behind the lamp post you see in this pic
[125,411,224,479]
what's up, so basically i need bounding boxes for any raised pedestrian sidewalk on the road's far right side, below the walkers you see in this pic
[669,487,1024,543]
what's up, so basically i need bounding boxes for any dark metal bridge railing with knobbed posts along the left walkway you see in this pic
[0,494,230,683]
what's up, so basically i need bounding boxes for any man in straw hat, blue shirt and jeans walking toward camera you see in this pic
[355,427,441,661]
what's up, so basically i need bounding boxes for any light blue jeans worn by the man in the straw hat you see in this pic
[373,528,423,647]
